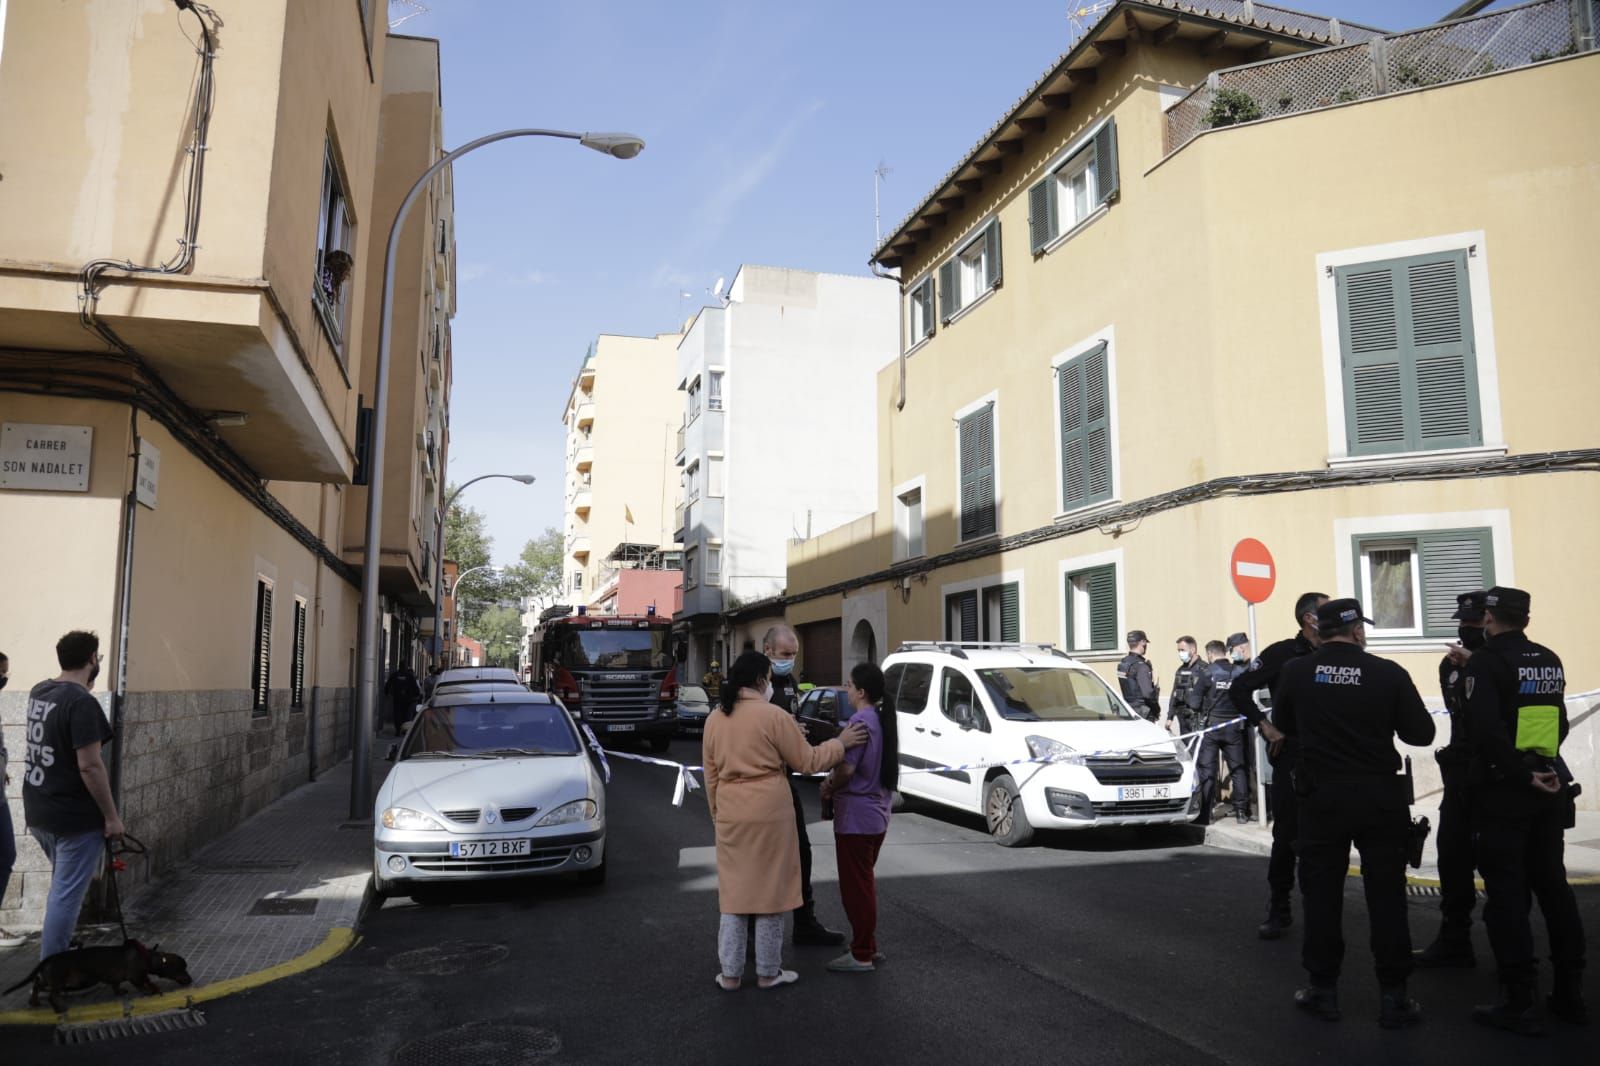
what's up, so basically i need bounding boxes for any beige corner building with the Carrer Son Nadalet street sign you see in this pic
[0,0,451,925]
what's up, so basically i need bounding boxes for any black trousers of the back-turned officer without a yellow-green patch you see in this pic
[1299,775,1411,988]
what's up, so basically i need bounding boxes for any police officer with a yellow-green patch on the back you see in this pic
[1462,587,1589,1036]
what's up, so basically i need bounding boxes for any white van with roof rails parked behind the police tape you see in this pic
[883,642,1197,847]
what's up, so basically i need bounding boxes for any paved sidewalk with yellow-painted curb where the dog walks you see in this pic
[0,759,384,1024]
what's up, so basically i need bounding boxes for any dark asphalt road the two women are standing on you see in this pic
[0,741,1600,1066]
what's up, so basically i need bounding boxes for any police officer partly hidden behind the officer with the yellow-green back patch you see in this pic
[1414,592,1485,968]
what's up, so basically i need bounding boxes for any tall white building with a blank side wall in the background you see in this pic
[675,266,896,680]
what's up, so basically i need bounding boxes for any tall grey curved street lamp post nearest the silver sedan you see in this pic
[350,130,645,820]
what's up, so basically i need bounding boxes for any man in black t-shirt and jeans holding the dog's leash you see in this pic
[22,631,123,959]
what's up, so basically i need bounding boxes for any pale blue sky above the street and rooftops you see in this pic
[394,0,1506,562]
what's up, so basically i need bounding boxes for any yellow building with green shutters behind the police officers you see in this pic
[786,0,1600,791]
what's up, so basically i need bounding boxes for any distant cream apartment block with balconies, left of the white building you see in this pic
[562,333,682,616]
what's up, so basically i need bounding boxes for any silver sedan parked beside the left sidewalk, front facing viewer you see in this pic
[373,690,606,896]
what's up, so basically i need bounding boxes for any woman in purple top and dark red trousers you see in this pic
[822,663,899,973]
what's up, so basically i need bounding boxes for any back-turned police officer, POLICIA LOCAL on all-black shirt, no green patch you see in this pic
[1272,600,1434,1029]
